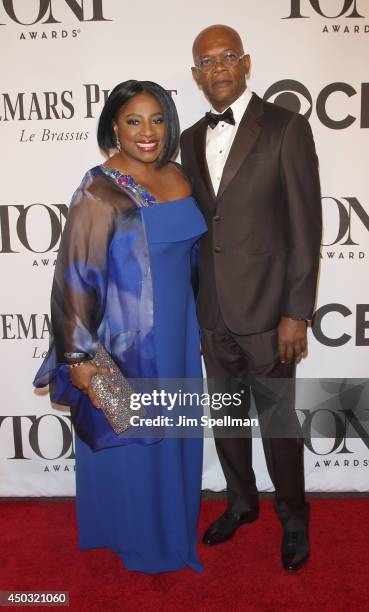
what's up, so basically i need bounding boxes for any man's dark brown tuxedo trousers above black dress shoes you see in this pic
[202,315,308,531]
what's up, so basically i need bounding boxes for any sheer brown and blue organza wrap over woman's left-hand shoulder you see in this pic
[34,166,157,448]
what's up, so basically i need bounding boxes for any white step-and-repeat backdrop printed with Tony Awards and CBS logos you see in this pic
[0,0,369,496]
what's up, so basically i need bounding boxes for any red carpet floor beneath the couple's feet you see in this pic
[0,499,369,612]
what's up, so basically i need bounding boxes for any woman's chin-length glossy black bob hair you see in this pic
[97,79,180,168]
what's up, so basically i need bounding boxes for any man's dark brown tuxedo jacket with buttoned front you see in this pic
[181,94,321,334]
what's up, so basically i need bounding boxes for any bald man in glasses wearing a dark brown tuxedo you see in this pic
[181,25,321,571]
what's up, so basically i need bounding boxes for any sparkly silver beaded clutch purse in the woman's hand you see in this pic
[91,344,146,435]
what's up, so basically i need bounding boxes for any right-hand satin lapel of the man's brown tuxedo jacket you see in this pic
[217,94,263,198]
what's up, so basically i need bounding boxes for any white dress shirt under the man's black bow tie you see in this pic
[206,89,252,194]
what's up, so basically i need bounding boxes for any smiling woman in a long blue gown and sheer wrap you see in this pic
[35,81,206,573]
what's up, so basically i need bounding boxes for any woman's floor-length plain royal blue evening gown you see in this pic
[76,197,206,573]
